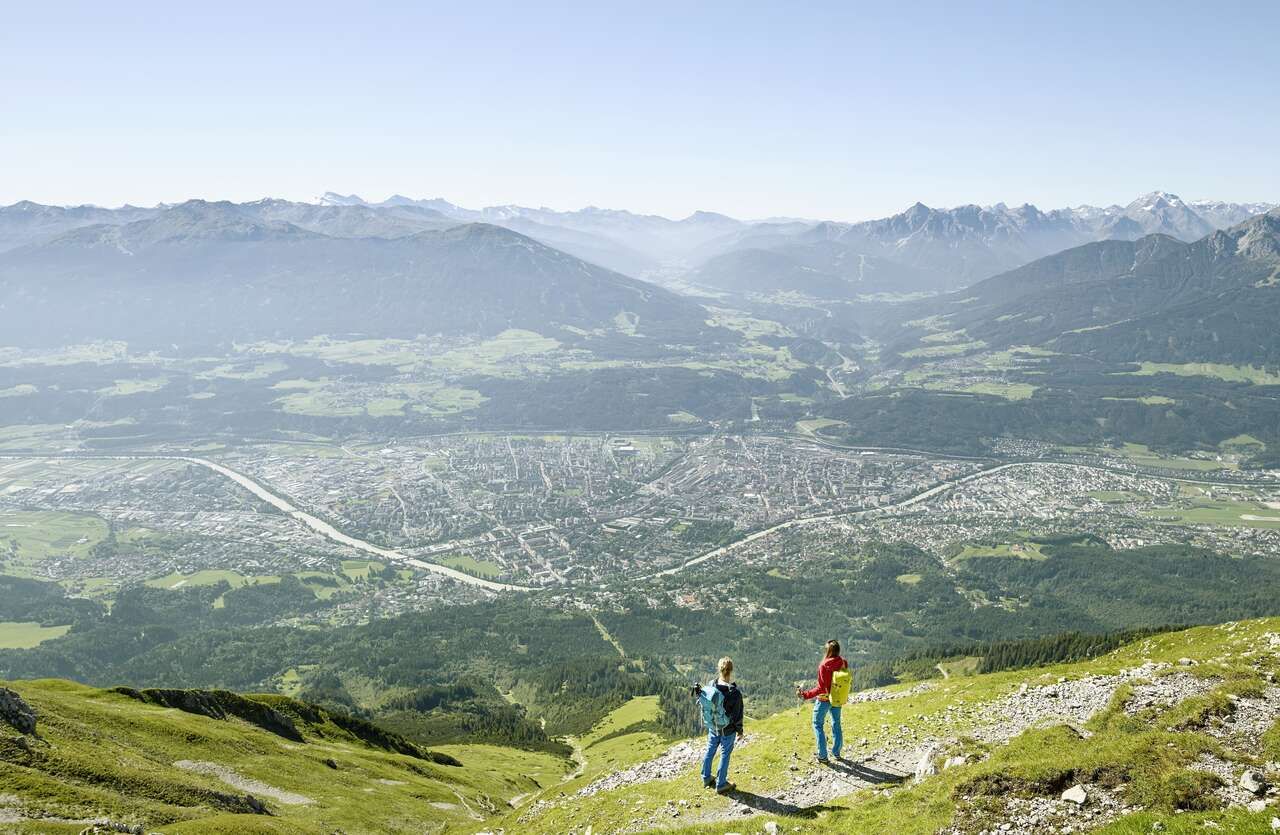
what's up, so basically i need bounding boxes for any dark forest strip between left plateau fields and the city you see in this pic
[0,355,778,440]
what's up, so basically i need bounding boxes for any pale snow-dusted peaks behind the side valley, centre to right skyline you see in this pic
[307,191,1275,298]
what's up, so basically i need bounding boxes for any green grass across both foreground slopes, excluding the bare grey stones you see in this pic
[0,619,1280,835]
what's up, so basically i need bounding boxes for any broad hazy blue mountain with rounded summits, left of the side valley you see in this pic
[0,201,705,346]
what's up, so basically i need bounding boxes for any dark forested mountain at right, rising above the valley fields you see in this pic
[891,210,1280,365]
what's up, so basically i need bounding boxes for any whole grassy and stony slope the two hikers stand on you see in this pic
[506,619,1280,835]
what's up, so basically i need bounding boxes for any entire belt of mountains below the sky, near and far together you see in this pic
[0,192,1280,362]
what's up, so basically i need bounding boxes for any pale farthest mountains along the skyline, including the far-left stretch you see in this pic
[0,191,1275,298]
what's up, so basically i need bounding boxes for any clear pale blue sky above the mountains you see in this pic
[0,0,1280,219]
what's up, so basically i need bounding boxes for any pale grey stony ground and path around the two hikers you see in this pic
[521,645,1280,835]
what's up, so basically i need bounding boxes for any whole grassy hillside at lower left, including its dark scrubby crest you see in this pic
[0,679,562,835]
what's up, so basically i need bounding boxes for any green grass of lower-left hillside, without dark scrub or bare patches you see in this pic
[0,680,564,835]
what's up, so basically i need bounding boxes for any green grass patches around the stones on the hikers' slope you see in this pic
[504,619,1280,835]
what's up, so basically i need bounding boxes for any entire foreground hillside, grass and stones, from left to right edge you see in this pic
[0,619,1280,835]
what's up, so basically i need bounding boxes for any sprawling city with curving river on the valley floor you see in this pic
[0,433,1280,622]
